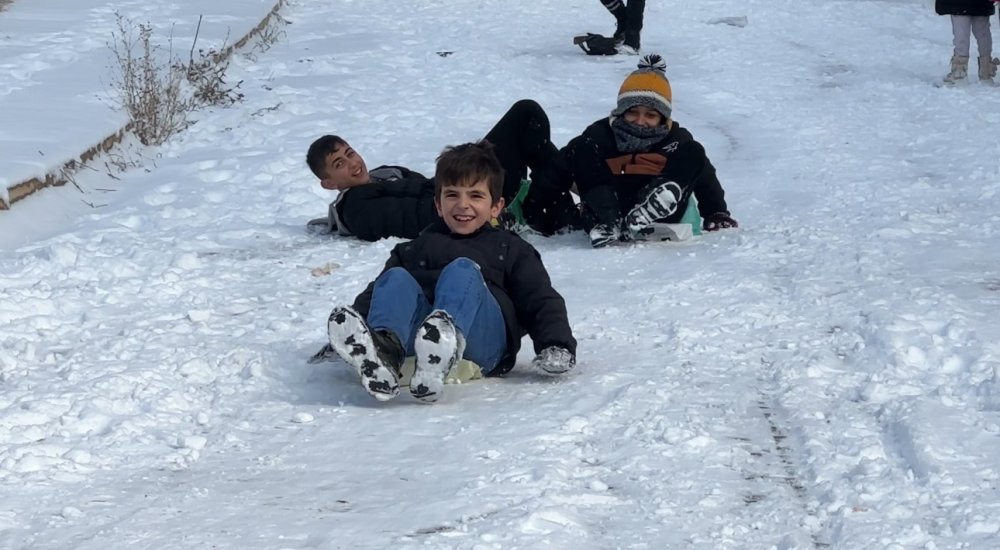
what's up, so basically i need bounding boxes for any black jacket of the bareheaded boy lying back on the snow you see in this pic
[334,166,440,241]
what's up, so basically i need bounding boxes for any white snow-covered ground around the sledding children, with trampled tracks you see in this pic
[0,0,1000,549]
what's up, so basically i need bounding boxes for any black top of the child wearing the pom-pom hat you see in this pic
[531,118,728,229]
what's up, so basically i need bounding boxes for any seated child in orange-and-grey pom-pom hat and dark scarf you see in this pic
[523,54,737,248]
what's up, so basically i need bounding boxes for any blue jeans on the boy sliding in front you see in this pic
[367,258,507,374]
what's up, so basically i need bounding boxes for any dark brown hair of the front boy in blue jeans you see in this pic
[434,139,503,204]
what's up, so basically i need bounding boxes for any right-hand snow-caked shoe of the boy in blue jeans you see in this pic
[410,309,465,403]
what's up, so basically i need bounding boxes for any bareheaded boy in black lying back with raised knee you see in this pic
[306,100,571,241]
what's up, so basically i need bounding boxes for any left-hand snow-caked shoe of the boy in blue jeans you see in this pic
[327,307,404,401]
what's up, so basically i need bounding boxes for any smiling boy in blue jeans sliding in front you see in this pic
[328,141,576,403]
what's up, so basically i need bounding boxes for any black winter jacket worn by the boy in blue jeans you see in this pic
[354,219,576,375]
